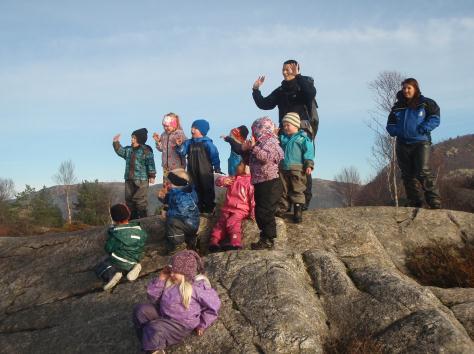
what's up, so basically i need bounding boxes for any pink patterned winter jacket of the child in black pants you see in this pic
[249,135,284,184]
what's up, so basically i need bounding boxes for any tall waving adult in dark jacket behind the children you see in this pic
[252,60,319,210]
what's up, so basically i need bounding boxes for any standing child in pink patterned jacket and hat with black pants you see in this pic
[242,117,283,250]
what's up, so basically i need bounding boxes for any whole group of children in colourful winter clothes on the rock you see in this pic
[95,113,314,352]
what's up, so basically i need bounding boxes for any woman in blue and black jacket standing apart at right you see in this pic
[387,78,441,209]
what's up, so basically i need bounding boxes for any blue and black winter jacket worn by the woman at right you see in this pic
[387,91,440,144]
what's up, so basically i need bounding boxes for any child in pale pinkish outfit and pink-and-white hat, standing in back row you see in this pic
[153,112,186,183]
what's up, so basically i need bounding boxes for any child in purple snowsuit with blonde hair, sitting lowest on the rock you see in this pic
[133,251,221,353]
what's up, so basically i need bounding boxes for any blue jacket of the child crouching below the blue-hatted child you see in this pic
[163,185,199,229]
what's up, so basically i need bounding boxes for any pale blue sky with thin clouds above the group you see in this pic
[0,0,474,191]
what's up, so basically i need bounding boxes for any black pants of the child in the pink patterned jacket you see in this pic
[254,178,283,240]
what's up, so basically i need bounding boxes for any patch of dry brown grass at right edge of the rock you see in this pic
[406,243,474,288]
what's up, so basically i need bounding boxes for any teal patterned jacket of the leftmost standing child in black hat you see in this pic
[113,141,156,181]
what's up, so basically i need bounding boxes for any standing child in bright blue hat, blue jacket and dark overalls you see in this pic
[176,119,222,215]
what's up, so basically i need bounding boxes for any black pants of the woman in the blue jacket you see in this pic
[397,142,441,207]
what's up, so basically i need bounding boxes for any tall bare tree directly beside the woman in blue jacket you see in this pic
[367,71,404,207]
